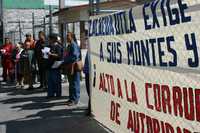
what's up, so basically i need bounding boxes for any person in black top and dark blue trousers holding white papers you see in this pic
[47,34,63,98]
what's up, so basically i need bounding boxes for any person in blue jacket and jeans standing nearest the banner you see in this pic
[64,32,81,106]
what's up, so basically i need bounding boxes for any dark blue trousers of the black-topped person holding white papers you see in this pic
[47,69,62,97]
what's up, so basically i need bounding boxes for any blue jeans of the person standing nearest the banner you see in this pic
[68,72,80,102]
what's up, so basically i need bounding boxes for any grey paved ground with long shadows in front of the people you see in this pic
[0,69,107,133]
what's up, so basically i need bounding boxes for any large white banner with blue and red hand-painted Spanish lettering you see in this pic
[89,0,200,133]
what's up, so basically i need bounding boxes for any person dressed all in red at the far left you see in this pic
[0,38,14,82]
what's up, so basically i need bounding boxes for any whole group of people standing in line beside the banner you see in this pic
[0,31,90,111]
